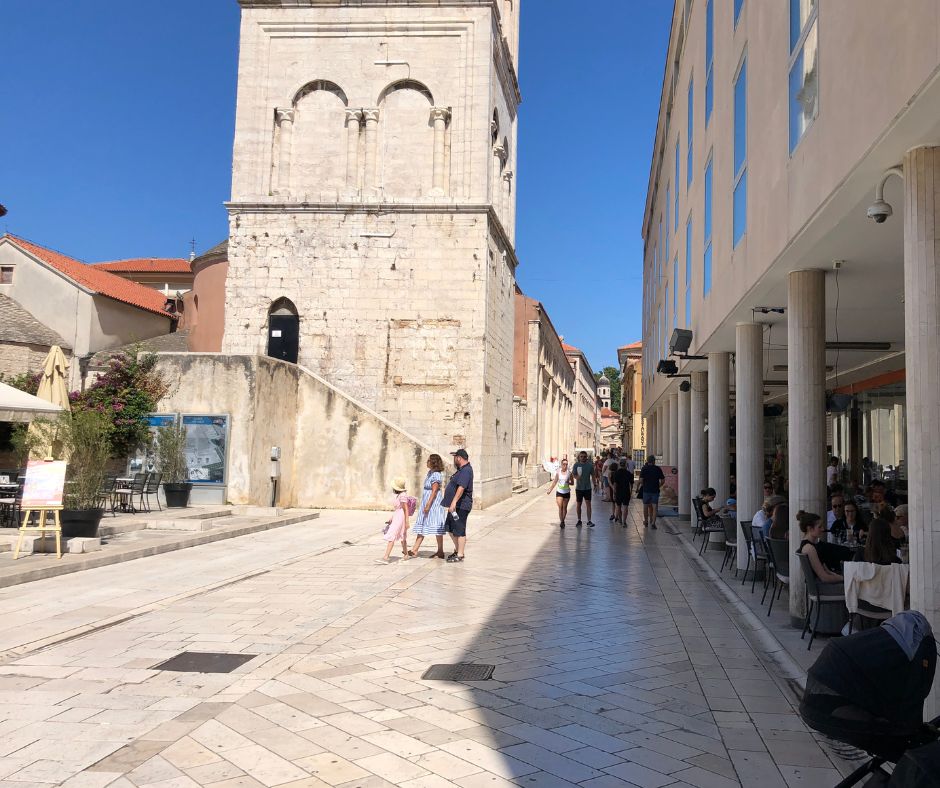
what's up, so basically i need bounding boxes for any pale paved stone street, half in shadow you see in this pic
[0,490,838,788]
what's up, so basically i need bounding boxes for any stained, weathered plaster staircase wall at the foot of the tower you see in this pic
[158,353,443,509]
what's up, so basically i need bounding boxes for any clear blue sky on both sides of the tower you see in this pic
[0,0,672,376]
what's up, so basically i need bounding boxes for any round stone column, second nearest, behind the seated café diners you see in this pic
[787,270,828,624]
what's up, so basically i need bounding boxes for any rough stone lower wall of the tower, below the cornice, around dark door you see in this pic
[223,211,514,502]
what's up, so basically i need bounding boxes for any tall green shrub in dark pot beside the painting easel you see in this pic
[55,411,111,538]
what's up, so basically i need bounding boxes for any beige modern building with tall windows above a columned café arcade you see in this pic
[642,0,940,711]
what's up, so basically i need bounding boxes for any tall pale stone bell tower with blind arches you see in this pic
[222,0,520,504]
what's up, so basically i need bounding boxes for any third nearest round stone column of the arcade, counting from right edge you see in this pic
[734,323,764,569]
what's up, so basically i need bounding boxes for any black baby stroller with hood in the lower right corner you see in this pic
[800,611,940,788]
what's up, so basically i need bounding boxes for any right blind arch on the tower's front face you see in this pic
[379,79,434,200]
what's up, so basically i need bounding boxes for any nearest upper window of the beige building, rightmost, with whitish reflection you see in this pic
[790,0,819,153]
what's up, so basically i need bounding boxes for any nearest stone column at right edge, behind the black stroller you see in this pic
[904,148,940,717]
